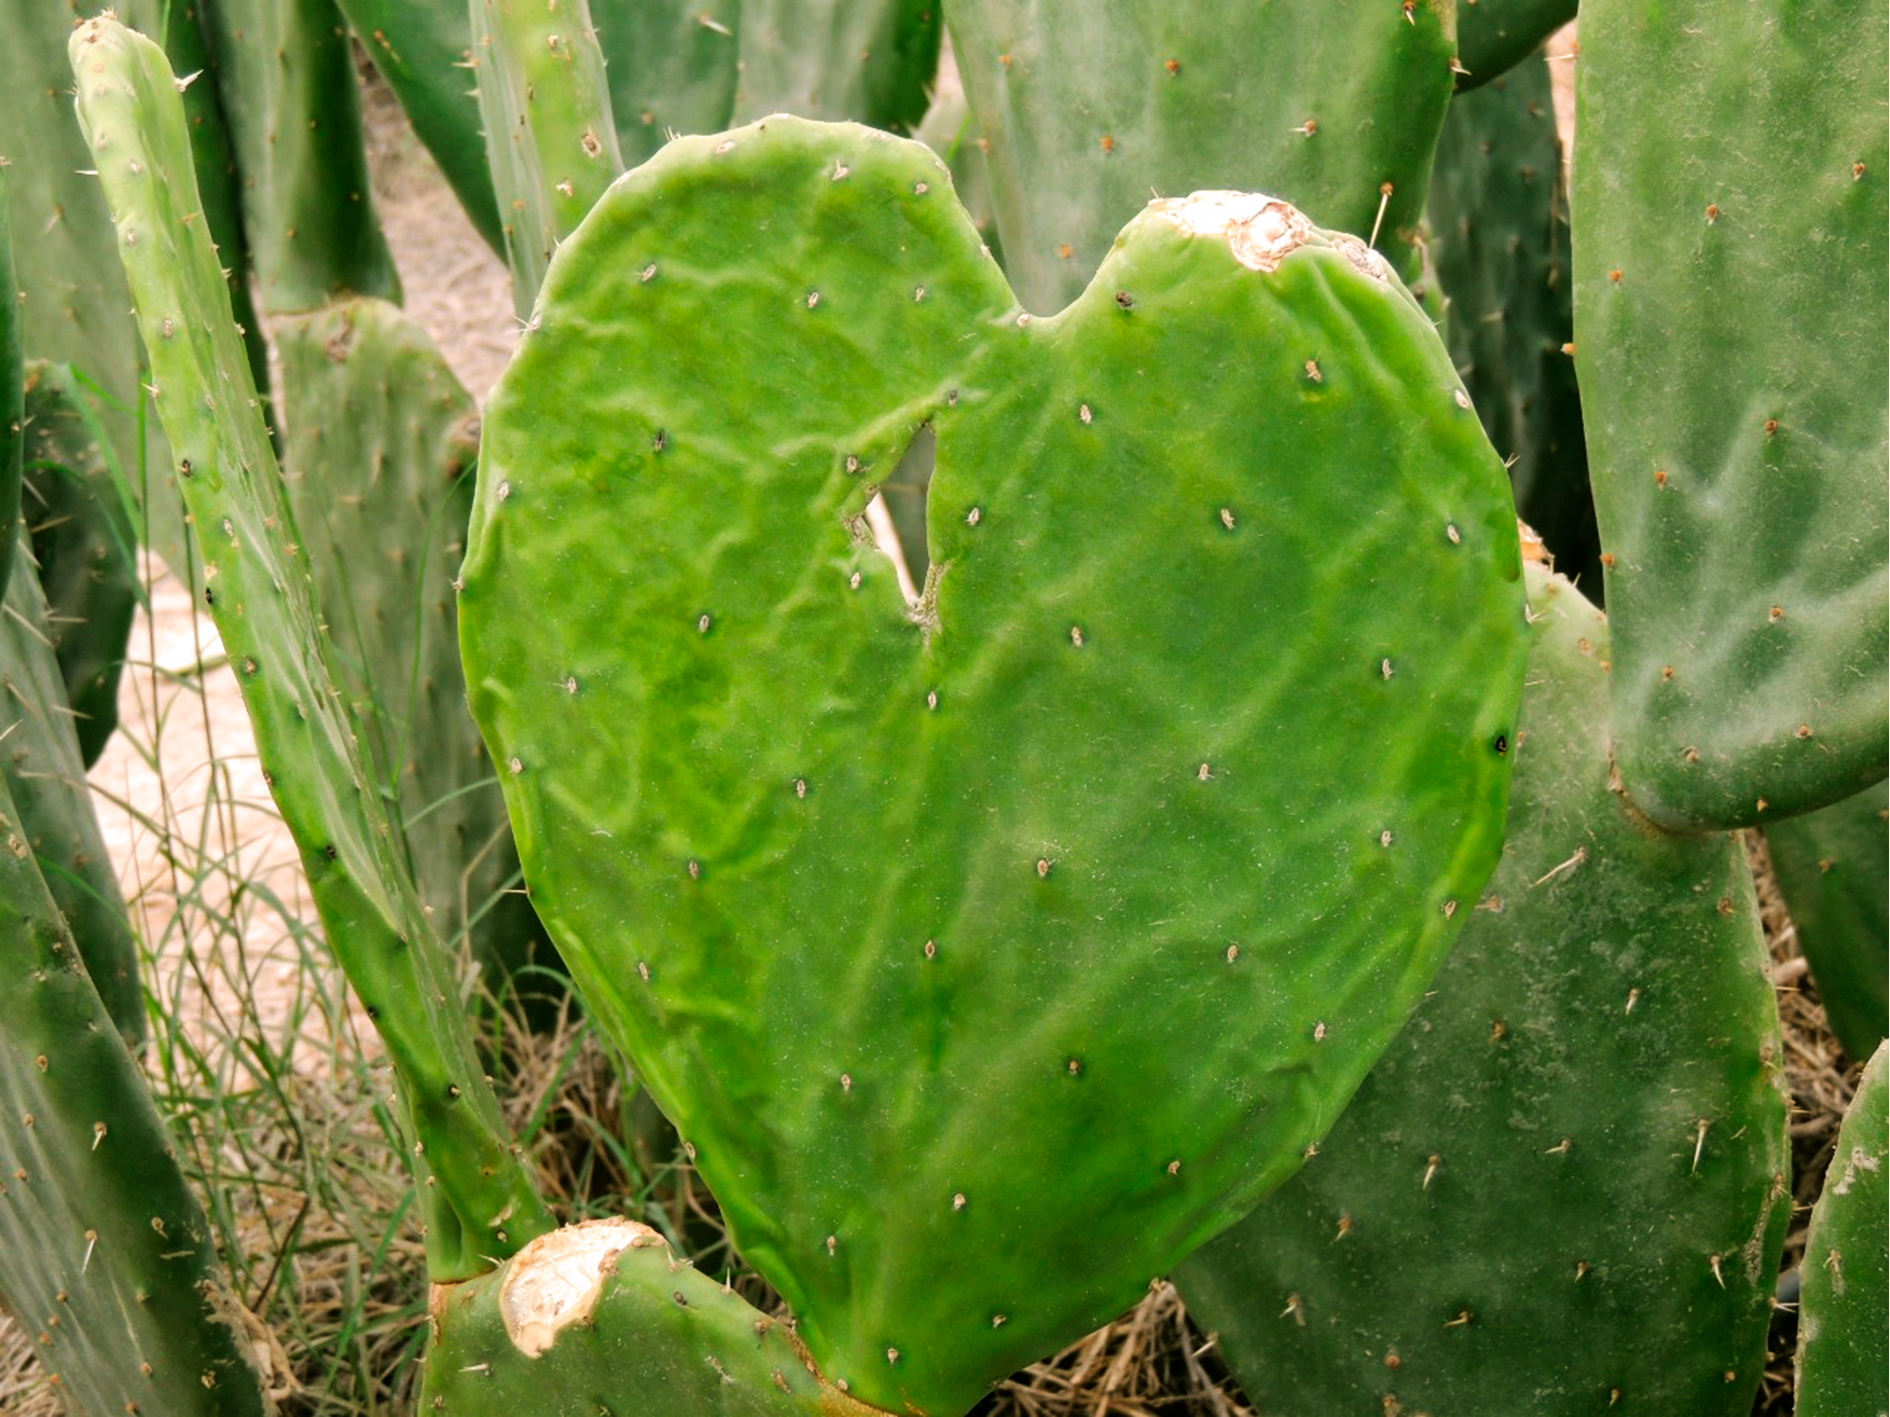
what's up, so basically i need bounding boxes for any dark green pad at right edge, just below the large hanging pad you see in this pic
[1765,782,1890,1058]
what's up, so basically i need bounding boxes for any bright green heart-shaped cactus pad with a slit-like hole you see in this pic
[459,117,1525,1417]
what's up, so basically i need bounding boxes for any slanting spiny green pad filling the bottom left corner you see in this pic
[0,770,266,1417]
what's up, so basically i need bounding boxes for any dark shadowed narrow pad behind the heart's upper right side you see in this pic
[1431,55,1601,589]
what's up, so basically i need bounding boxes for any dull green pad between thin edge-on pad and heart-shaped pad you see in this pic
[276,299,558,990]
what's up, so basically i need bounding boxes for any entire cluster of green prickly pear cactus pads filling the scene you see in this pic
[0,0,1890,1417]
